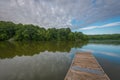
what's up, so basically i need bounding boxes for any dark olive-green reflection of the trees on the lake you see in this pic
[0,41,85,58]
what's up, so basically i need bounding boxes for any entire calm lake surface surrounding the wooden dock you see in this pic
[0,41,120,80]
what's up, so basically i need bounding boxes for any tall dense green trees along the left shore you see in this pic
[0,21,88,41]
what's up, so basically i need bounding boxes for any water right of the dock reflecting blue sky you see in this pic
[73,42,120,80]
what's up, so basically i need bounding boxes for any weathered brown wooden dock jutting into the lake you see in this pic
[64,52,110,80]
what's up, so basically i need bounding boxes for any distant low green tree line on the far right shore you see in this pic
[88,34,120,40]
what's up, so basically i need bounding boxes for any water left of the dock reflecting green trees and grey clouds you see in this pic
[0,41,85,80]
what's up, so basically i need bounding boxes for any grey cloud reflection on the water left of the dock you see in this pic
[0,51,71,80]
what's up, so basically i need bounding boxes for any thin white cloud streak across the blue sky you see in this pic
[79,22,120,30]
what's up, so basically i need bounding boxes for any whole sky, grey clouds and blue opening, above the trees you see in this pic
[0,0,120,34]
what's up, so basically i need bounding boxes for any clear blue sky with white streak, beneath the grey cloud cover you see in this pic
[71,16,120,34]
